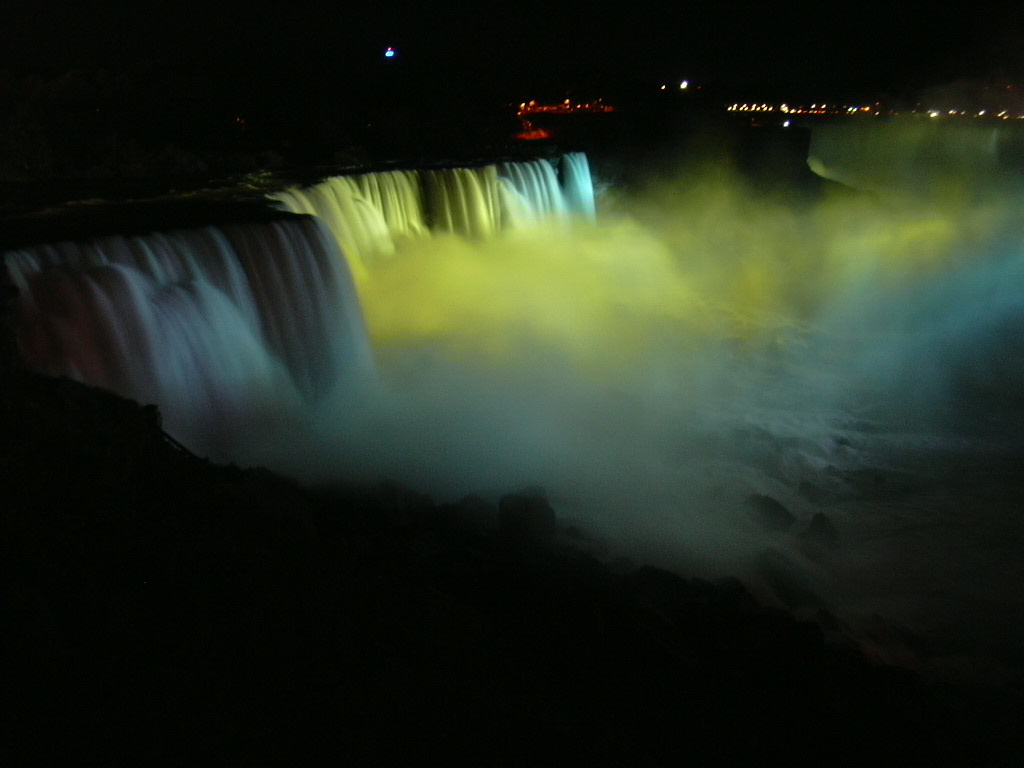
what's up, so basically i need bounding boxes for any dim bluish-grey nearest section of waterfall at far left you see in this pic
[6,218,373,454]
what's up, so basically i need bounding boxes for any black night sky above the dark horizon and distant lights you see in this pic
[0,0,1024,97]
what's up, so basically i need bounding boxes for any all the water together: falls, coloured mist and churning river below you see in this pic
[6,132,1024,676]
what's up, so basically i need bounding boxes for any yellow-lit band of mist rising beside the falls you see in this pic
[359,164,991,376]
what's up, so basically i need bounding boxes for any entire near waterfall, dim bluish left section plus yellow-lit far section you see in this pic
[5,158,593,456]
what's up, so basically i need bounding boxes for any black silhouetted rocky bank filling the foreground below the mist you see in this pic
[0,374,1021,766]
